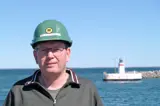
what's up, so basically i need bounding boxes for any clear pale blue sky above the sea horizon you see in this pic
[0,0,160,68]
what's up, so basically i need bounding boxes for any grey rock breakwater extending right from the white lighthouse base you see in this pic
[140,70,160,78]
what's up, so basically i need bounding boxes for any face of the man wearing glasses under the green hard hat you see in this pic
[34,41,70,73]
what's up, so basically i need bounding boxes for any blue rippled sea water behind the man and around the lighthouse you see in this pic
[0,67,160,106]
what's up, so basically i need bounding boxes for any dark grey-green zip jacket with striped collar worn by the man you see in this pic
[3,69,103,106]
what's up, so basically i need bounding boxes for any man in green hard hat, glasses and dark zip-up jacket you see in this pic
[4,20,103,106]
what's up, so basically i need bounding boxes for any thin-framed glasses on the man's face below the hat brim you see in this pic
[36,48,66,56]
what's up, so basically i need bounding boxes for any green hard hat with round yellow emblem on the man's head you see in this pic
[31,20,72,48]
